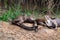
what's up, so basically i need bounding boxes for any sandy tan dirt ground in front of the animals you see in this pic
[0,21,60,40]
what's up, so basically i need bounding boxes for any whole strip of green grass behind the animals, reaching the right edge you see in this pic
[0,5,60,21]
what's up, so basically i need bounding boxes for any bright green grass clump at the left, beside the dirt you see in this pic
[0,4,21,21]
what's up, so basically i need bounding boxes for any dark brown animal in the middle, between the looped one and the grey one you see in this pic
[24,18,46,26]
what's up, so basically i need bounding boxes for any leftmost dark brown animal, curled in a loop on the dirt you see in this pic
[12,15,38,32]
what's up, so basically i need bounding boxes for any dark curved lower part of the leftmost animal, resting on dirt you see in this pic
[12,21,38,32]
